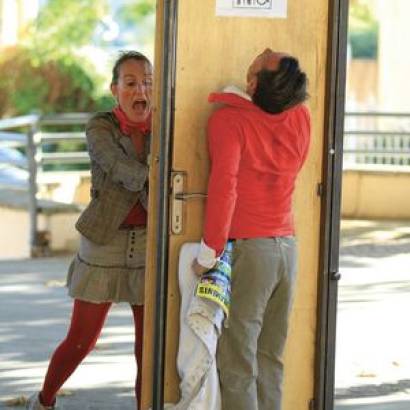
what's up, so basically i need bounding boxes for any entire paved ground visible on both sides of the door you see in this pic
[0,221,410,410]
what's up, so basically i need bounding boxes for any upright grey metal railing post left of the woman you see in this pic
[26,119,39,257]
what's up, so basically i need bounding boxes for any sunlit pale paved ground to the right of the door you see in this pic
[335,221,410,410]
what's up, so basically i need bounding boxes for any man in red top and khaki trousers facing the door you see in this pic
[195,49,310,410]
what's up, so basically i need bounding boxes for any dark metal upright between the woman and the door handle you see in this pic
[152,0,177,410]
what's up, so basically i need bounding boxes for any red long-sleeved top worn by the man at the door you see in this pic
[202,92,310,260]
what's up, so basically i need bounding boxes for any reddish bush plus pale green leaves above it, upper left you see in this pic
[0,0,113,116]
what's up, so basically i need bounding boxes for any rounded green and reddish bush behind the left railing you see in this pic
[0,47,110,117]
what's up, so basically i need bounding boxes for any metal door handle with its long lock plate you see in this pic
[171,171,207,235]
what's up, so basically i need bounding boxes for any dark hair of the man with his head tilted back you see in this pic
[252,57,308,114]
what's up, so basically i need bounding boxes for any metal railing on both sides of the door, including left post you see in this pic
[0,112,410,255]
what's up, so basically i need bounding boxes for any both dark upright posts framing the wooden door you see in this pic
[152,0,349,410]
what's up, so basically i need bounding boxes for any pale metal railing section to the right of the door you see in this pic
[343,112,410,167]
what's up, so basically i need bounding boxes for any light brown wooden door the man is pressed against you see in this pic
[143,0,344,410]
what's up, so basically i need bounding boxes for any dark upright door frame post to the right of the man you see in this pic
[310,0,349,410]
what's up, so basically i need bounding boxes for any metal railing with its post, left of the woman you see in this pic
[0,113,91,255]
